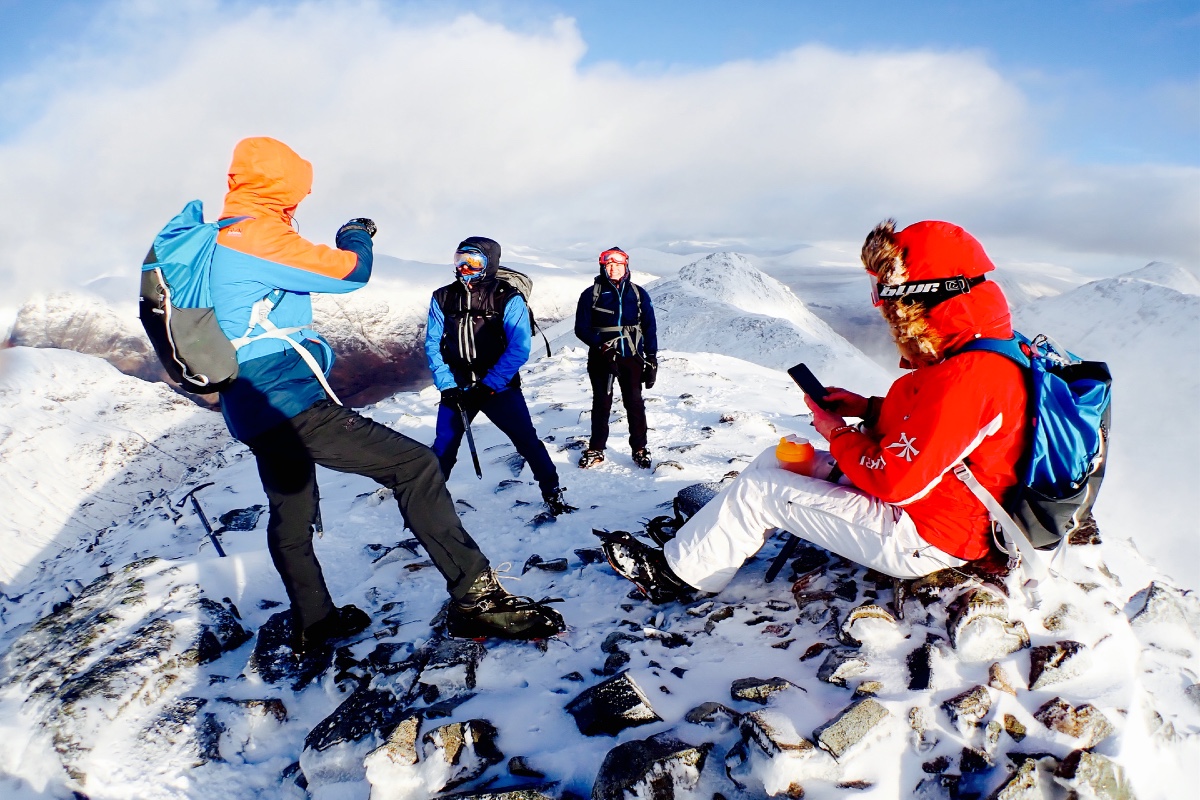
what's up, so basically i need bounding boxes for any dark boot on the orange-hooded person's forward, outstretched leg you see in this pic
[446,569,566,639]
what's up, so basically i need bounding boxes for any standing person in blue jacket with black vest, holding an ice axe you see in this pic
[425,236,575,517]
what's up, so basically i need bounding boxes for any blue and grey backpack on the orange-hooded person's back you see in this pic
[138,200,245,393]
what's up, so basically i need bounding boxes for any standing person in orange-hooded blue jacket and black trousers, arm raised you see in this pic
[211,137,564,657]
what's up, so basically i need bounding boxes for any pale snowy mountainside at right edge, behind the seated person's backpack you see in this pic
[1014,264,1200,589]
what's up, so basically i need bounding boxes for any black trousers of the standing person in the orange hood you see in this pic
[246,401,488,628]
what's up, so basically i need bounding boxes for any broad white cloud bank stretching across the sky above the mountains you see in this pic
[0,2,1200,302]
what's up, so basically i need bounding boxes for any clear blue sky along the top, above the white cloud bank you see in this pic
[0,0,1200,164]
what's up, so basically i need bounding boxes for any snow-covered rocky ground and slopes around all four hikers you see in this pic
[0,257,1200,800]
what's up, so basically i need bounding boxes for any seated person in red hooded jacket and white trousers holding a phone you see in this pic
[605,219,1028,602]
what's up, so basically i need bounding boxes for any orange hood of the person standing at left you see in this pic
[221,137,312,224]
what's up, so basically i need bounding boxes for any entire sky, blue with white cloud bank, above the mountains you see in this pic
[0,0,1200,302]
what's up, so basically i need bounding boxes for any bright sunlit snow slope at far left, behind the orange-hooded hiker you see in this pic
[0,348,228,590]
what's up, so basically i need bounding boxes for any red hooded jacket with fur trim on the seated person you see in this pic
[829,222,1028,560]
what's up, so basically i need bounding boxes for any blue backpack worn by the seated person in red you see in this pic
[955,333,1112,566]
